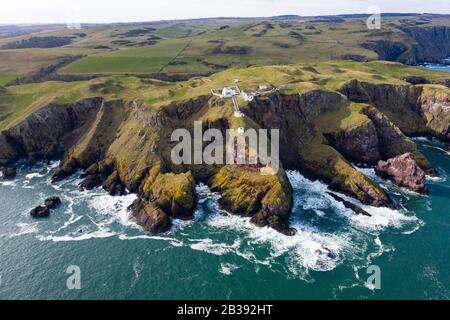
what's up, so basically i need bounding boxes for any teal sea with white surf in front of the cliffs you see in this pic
[0,139,450,299]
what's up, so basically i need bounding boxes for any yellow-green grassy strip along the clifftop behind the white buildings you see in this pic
[0,61,448,130]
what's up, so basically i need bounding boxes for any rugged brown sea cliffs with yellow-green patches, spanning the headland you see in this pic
[0,75,450,235]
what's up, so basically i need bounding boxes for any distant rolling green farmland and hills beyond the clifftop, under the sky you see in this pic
[0,16,450,79]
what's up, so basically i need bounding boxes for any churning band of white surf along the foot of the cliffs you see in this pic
[2,163,422,285]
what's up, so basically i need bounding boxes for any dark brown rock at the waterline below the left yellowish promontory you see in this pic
[128,199,171,232]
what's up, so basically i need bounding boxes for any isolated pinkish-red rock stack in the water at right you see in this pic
[375,153,428,194]
